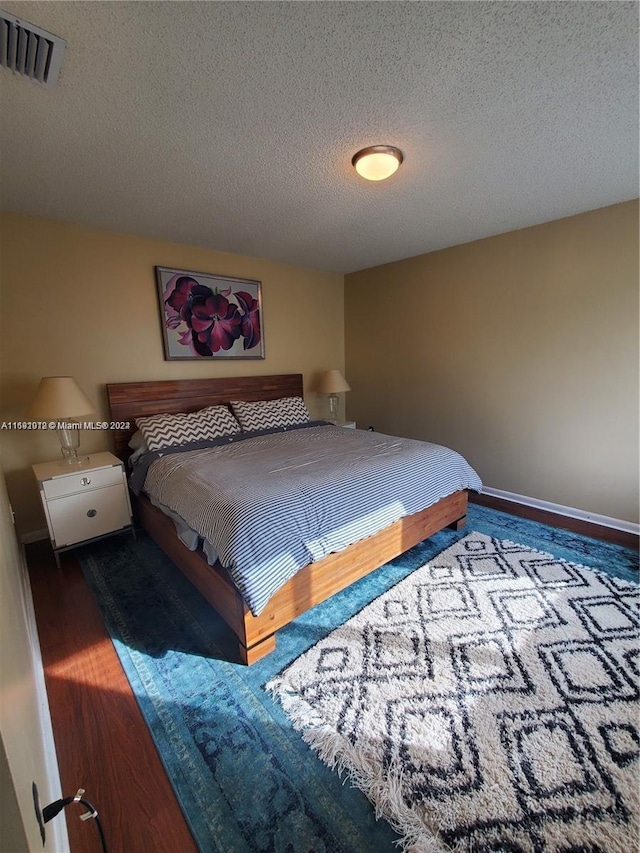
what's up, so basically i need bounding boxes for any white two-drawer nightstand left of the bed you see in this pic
[33,453,135,566]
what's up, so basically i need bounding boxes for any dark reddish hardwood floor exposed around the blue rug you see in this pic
[26,495,638,853]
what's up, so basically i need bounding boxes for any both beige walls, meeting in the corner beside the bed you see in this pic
[0,202,638,533]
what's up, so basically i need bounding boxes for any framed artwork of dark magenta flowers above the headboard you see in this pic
[156,267,264,361]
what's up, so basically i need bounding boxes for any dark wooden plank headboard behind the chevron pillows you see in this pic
[107,373,302,460]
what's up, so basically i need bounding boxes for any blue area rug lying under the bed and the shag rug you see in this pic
[78,505,638,853]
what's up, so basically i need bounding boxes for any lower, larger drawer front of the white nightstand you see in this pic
[47,480,131,548]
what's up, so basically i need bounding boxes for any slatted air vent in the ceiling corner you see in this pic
[0,10,65,86]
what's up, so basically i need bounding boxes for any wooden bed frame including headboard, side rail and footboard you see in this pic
[107,374,467,665]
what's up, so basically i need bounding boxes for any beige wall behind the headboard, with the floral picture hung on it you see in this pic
[0,214,344,533]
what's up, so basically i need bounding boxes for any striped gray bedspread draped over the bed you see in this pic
[144,426,482,616]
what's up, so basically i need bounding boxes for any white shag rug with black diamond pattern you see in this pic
[267,533,640,853]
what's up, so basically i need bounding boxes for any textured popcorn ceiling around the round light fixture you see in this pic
[0,0,638,272]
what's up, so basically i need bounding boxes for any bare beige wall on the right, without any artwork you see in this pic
[345,202,638,523]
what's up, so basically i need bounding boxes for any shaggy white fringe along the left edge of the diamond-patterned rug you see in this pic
[265,678,466,853]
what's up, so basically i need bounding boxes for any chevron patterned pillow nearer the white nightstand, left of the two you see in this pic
[136,406,240,450]
